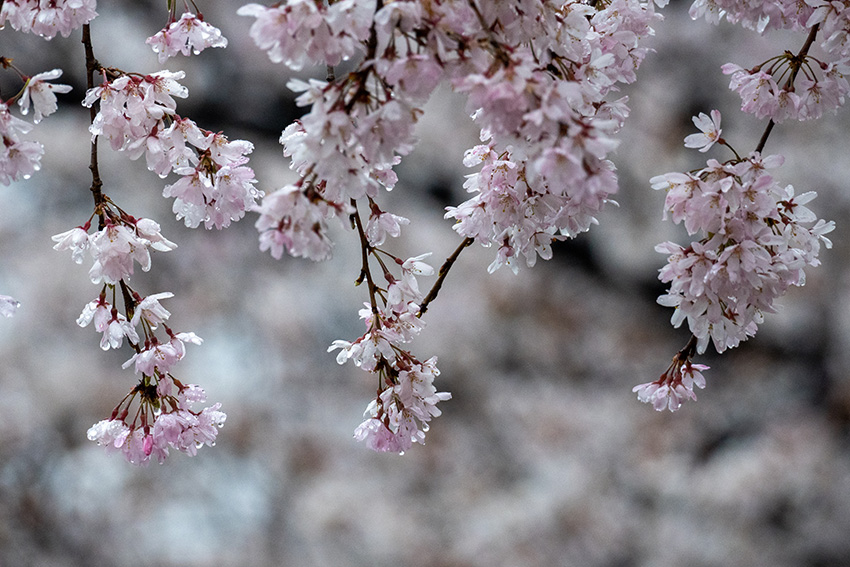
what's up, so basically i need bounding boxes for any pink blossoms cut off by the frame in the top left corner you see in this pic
[0,0,97,39]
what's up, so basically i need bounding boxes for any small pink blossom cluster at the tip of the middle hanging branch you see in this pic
[328,254,451,453]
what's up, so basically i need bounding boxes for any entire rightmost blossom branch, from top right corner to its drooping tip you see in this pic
[634,0,850,411]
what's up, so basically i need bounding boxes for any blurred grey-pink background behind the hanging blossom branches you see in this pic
[0,1,850,567]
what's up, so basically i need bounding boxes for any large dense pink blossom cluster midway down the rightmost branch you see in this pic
[651,115,834,352]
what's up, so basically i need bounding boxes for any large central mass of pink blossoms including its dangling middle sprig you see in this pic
[238,0,660,452]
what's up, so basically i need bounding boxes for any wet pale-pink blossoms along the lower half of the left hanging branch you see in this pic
[53,208,226,465]
